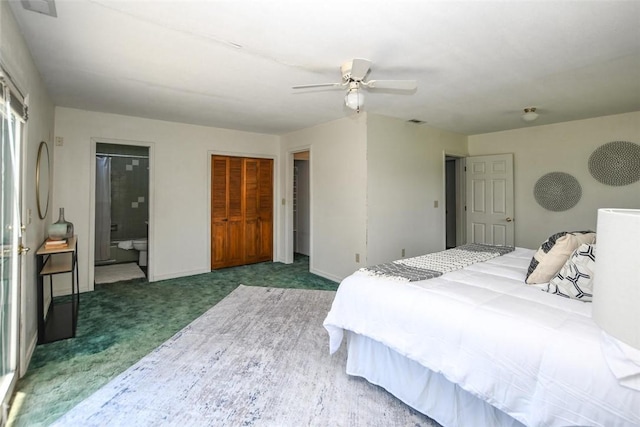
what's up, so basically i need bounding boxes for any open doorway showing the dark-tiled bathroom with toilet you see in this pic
[94,142,149,284]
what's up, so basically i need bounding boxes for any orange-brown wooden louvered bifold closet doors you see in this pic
[211,156,273,270]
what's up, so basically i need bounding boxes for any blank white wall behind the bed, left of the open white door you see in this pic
[366,114,467,265]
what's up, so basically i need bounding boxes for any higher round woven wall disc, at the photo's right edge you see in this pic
[589,141,640,186]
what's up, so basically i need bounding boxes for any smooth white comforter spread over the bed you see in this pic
[324,248,640,427]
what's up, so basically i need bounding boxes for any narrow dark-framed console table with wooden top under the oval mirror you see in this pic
[36,236,80,344]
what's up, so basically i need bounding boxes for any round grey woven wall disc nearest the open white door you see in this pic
[533,172,582,212]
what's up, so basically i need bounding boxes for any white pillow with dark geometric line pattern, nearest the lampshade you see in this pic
[543,243,596,302]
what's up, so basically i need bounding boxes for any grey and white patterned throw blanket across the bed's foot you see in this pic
[358,243,514,282]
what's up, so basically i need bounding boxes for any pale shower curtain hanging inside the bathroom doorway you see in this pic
[95,156,111,261]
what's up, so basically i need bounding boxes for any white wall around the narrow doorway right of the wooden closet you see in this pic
[280,113,367,281]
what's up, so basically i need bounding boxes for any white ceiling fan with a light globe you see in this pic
[293,58,418,113]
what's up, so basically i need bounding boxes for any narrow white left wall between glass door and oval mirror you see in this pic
[0,1,54,375]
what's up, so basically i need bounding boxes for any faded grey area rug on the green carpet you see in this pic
[54,285,437,426]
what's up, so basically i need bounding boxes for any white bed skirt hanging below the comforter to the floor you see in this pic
[345,331,523,427]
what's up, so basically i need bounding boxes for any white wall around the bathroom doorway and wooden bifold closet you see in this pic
[53,107,280,291]
